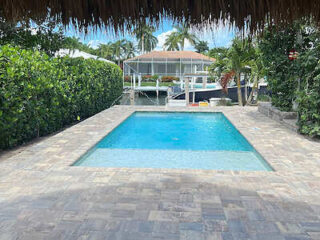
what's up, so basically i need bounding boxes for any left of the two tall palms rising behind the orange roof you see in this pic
[133,24,158,53]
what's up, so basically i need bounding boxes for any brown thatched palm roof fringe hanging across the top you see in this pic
[0,0,320,31]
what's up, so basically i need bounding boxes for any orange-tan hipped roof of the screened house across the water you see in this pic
[126,51,216,62]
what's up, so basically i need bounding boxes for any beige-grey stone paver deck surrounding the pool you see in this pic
[0,106,320,240]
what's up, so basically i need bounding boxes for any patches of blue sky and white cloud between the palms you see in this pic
[65,20,236,50]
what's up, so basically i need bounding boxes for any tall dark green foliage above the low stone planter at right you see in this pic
[259,20,320,138]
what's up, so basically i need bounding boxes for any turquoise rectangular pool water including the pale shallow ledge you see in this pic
[74,112,272,171]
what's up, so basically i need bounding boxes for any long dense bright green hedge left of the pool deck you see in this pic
[0,46,122,149]
